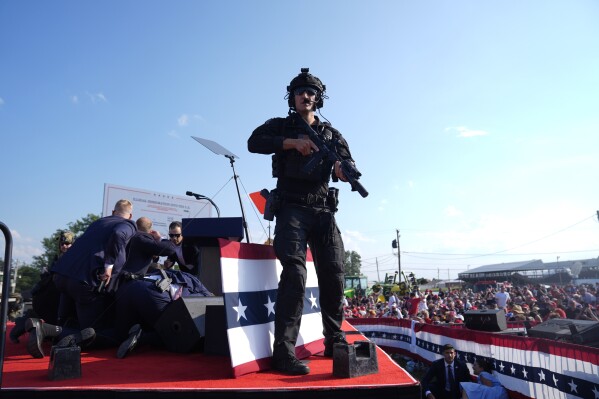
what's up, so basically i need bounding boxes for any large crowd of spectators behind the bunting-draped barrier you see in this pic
[344,283,599,324]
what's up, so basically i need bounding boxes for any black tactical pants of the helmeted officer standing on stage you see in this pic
[273,204,344,359]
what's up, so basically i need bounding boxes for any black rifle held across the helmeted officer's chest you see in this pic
[297,116,368,198]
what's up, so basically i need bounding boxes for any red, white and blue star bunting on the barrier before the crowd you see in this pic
[350,319,599,399]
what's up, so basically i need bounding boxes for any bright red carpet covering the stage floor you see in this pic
[2,323,418,398]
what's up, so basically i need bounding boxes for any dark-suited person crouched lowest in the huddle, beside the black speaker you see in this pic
[116,270,214,359]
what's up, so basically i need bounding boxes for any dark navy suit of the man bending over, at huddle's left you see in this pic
[52,215,137,328]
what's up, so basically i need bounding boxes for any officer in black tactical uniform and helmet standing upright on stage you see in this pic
[248,68,353,375]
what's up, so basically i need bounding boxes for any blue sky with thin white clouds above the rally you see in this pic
[0,0,599,279]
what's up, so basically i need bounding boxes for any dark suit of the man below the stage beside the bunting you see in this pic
[420,359,472,399]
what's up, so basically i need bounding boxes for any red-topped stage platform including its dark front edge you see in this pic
[0,323,420,399]
